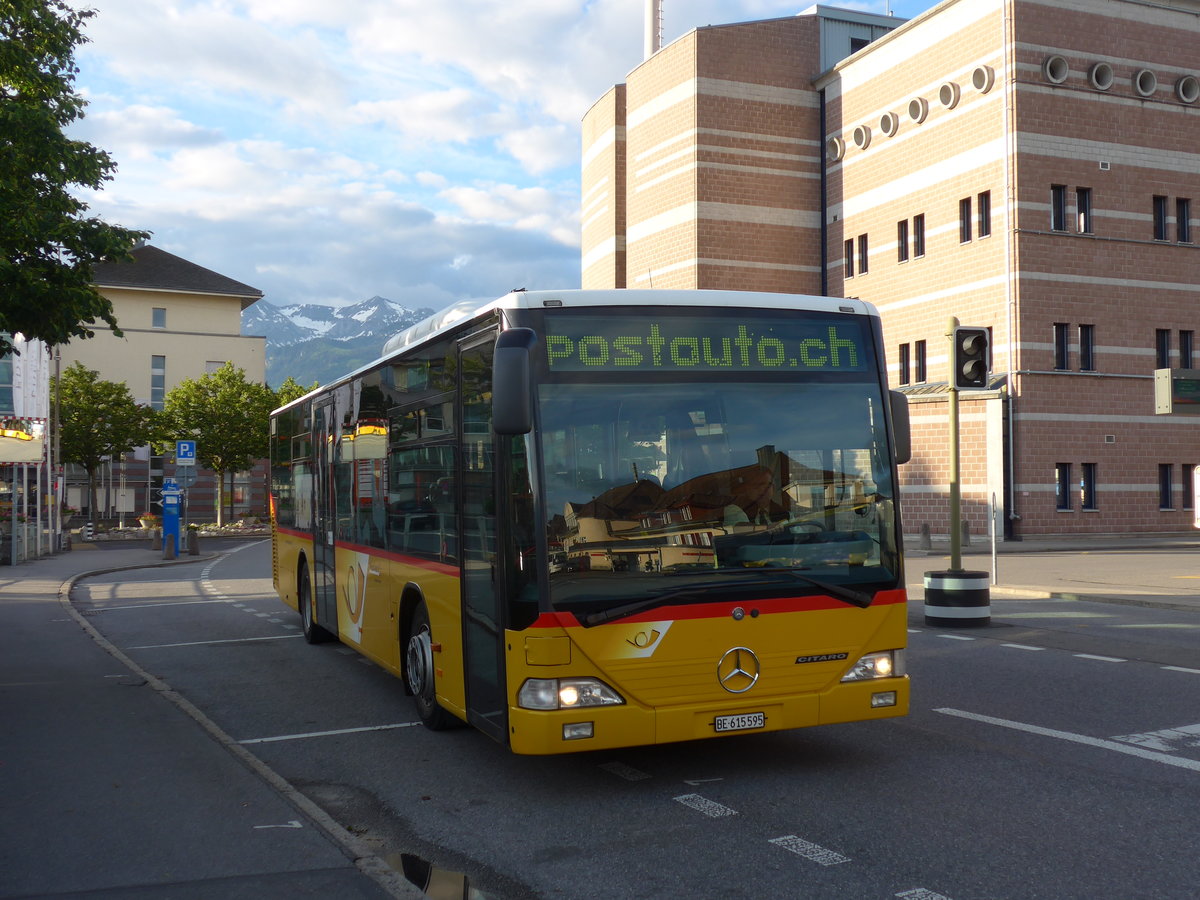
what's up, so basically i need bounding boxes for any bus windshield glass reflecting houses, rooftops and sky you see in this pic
[540,383,899,610]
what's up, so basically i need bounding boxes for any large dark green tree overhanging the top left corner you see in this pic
[0,0,148,354]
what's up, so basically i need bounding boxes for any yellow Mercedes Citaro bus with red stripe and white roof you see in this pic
[270,290,910,754]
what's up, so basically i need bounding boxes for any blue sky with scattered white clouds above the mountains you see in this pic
[73,0,934,307]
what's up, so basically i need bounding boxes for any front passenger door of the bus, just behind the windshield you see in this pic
[458,332,508,742]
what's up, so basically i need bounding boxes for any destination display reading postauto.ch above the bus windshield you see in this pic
[545,316,870,372]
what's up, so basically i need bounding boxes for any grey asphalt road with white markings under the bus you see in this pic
[73,542,1200,900]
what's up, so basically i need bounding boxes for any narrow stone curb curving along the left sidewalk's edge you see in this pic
[59,545,426,900]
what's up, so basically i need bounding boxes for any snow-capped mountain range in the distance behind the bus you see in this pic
[241,296,433,388]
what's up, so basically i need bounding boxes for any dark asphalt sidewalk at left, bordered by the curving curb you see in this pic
[0,542,424,900]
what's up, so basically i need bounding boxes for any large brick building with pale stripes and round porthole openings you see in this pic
[581,0,1200,538]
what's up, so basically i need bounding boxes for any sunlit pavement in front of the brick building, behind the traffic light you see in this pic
[905,532,1200,613]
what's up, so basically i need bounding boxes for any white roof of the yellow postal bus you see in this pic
[276,288,878,412]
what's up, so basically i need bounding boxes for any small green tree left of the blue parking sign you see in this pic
[54,362,156,517]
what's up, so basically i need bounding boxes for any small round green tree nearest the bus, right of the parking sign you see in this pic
[161,362,275,524]
